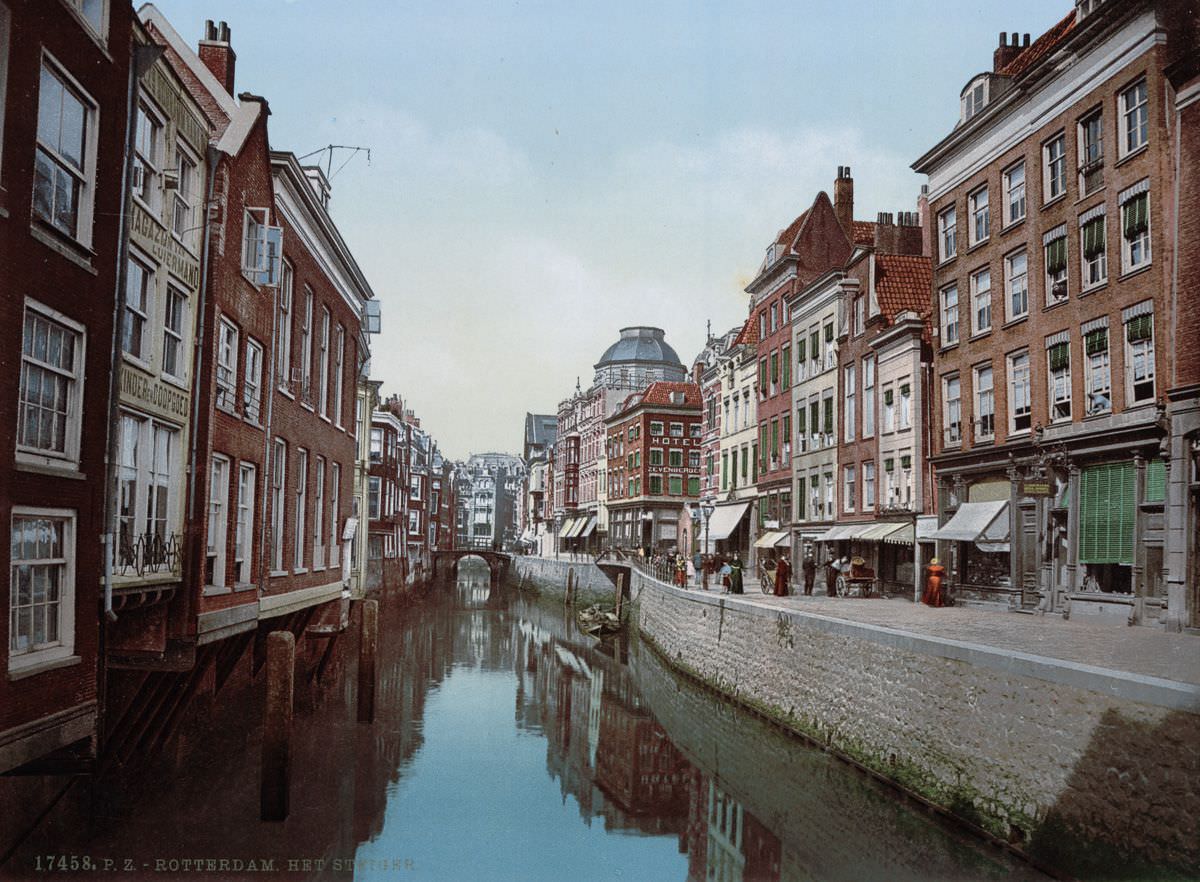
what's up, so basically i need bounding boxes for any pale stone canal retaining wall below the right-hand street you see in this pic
[632,571,1200,878]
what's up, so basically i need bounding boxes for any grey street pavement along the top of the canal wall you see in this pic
[691,588,1200,685]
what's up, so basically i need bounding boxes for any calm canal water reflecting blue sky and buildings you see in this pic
[0,562,1045,882]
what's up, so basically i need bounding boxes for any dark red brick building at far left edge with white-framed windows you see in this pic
[0,0,133,772]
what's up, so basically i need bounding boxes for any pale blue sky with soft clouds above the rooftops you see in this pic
[156,0,1073,458]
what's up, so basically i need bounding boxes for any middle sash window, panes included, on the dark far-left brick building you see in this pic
[17,300,84,463]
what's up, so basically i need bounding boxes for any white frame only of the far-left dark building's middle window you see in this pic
[13,298,88,470]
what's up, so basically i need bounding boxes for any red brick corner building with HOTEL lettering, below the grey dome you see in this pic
[605,382,703,551]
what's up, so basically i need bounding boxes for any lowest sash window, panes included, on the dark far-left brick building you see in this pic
[8,508,76,672]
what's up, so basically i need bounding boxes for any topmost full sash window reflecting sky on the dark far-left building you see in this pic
[34,60,96,245]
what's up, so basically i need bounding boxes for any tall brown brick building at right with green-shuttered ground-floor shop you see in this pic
[913,1,1195,623]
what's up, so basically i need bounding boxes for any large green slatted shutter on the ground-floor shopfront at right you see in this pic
[1079,462,1136,564]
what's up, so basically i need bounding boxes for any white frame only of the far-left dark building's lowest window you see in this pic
[6,505,77,674]
